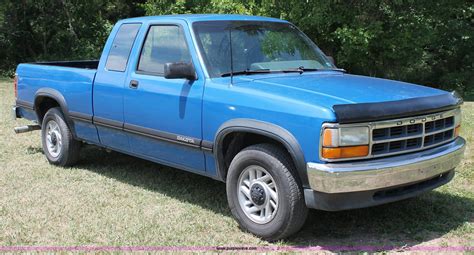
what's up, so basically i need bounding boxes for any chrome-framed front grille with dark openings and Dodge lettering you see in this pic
[371,113,455,156]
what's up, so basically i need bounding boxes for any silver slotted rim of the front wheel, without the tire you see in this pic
[237,165,278,224]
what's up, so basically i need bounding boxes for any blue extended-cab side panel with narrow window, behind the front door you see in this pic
[93,22,142,152]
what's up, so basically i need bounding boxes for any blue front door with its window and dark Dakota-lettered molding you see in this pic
[124,24,205,171]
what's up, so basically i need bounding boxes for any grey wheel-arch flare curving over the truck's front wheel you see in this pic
[213,119,309,187]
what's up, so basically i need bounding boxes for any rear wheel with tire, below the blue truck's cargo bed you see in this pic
[41,107,81,167]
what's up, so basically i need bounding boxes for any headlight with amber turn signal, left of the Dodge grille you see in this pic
[321,126,369,159]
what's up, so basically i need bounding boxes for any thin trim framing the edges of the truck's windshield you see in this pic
[190,20,336,78]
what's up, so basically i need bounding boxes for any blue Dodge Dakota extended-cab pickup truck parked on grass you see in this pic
[13,15,465,240]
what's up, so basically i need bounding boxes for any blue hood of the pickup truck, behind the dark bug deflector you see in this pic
[235,71,448,108]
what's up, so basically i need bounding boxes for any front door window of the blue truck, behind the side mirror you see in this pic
[137,25,191,75]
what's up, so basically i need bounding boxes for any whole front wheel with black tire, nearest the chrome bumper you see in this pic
[226,144,308,241]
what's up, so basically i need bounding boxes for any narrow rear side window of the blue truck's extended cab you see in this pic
[105,24,141,72]
